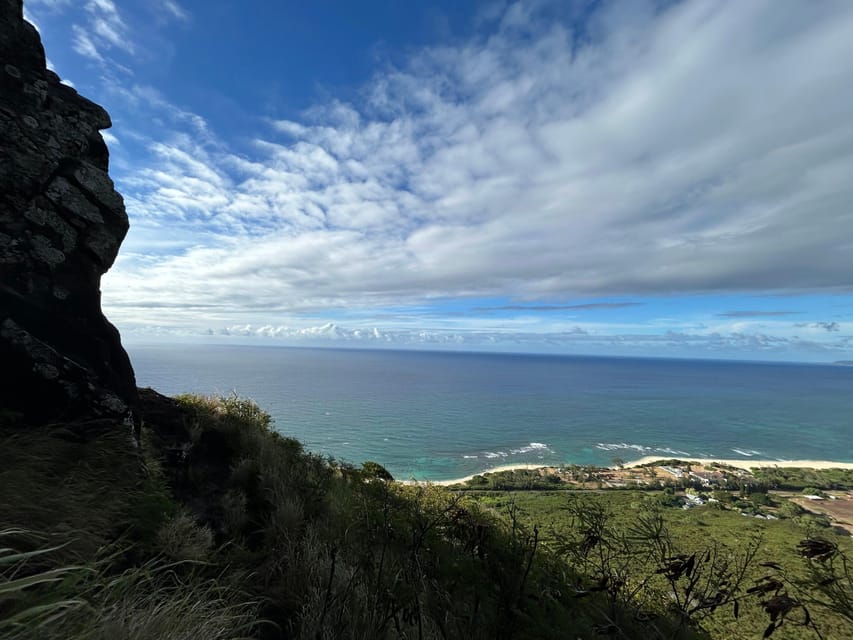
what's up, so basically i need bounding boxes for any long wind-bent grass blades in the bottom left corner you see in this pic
[0,529,258,640]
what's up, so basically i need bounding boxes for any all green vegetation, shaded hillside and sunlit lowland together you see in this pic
[0,396,853,640]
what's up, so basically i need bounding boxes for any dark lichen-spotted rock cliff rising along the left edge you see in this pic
[0,0,137,423]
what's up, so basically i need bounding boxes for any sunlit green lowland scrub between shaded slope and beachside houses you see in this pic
[470,490,853,639]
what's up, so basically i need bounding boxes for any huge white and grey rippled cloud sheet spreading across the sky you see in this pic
[95,0,853,340]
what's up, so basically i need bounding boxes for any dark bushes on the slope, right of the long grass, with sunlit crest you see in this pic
[166,396,608,639]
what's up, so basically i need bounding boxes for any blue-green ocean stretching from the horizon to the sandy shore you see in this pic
[128,345,853,480]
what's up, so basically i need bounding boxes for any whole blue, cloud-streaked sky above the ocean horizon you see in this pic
[24,0,853,362]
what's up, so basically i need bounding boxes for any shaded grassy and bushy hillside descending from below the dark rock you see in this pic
[0,396,640,640]
